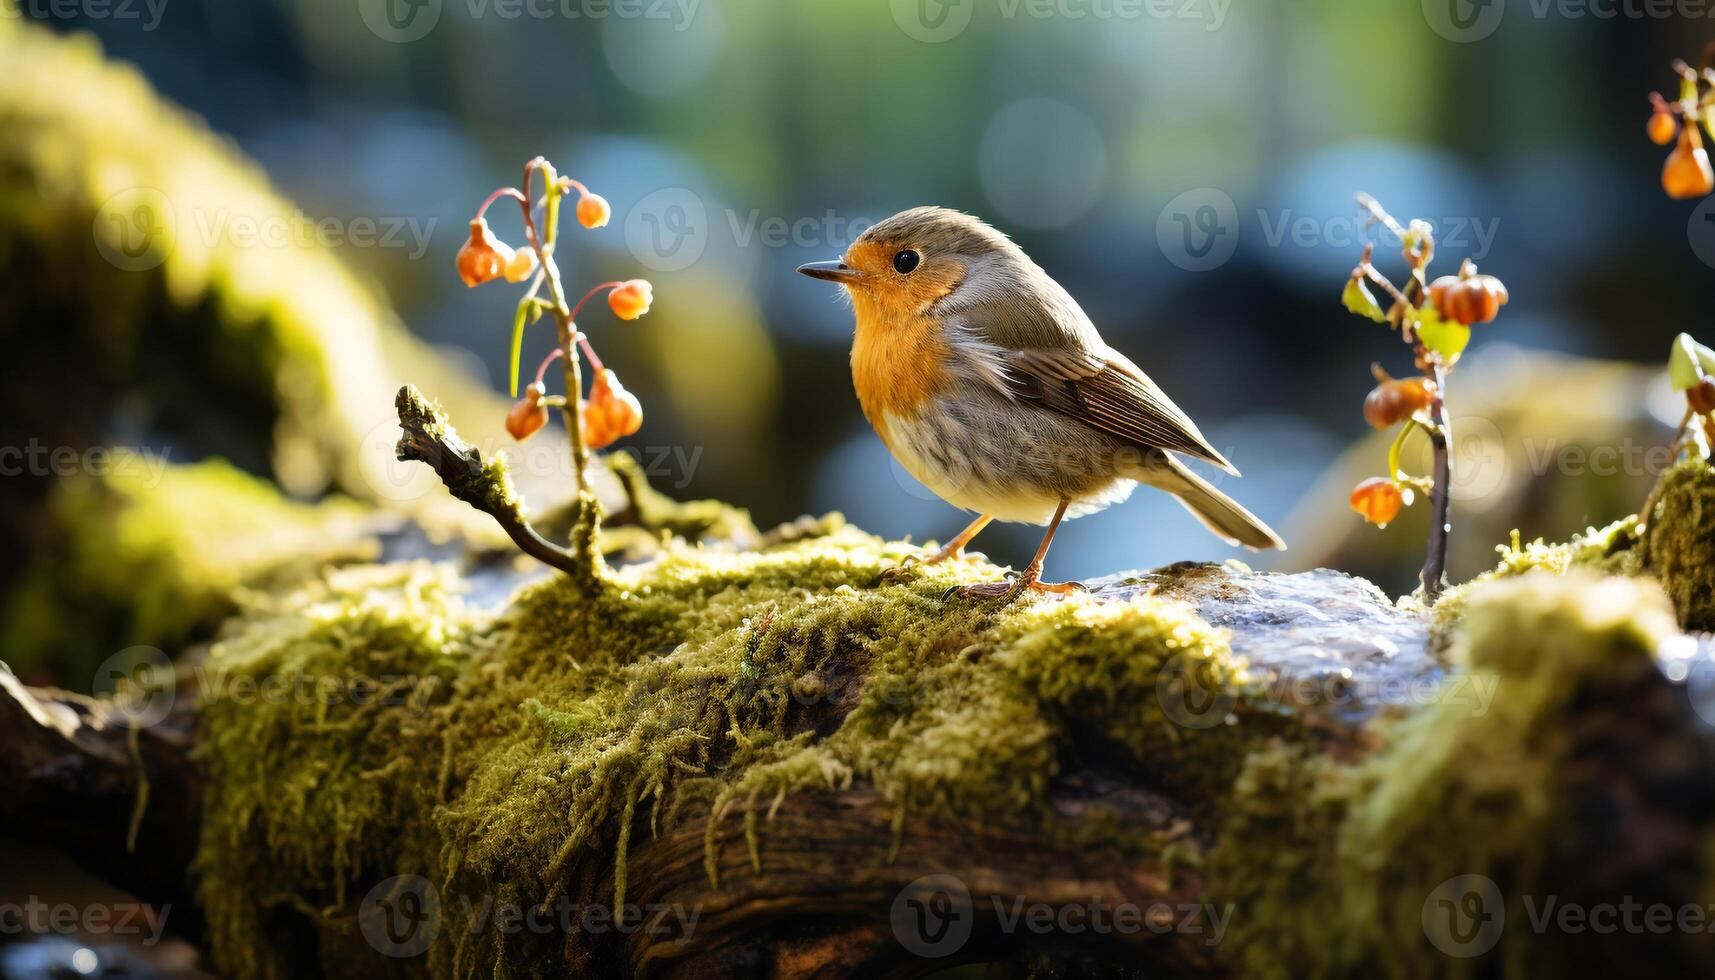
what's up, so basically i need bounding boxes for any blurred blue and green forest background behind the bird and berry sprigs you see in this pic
[0,0,1715,590]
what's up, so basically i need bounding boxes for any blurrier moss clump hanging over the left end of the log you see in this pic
[196,565,470,977]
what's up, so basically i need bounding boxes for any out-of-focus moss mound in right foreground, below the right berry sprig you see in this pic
[1209,572,1677,977]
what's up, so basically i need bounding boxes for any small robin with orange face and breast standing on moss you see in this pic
[797,208,1286,599]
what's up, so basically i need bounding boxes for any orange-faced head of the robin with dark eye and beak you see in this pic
[797,208,1031,323]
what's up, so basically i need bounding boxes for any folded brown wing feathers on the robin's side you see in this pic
[1005,347,1238,475]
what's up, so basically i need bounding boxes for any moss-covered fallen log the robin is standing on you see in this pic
[0,483,1715,977]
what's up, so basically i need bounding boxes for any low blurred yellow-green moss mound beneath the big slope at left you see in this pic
[0,451,377,687]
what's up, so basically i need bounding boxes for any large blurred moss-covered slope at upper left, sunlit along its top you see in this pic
[0,16,508,505]
